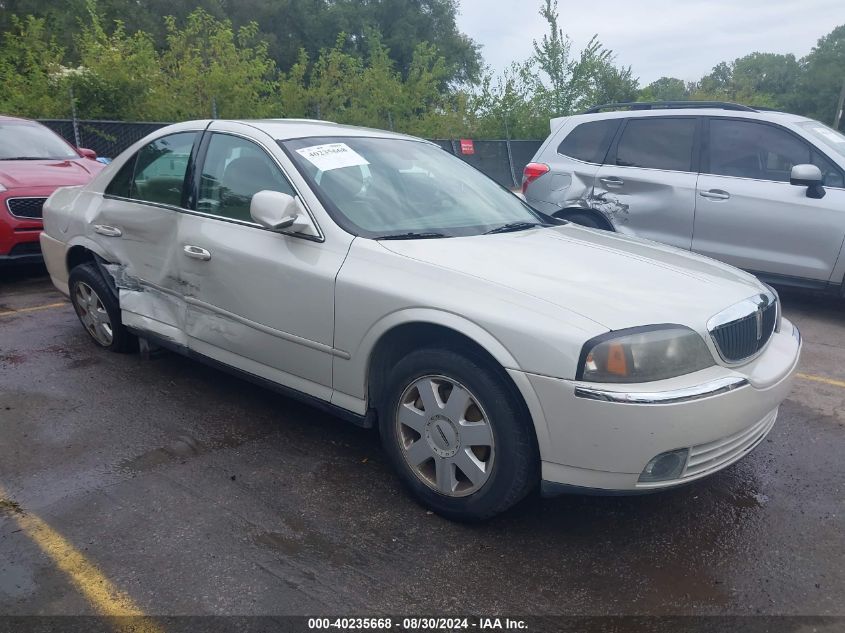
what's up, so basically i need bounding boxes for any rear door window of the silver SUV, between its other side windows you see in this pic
[616,118,696,171]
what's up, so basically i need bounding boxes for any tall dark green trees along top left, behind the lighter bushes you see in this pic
[0,0,481,83]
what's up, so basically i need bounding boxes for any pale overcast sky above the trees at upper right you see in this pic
[458,0,845,86]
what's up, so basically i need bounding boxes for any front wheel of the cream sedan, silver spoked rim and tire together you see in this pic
[379,349,539,520]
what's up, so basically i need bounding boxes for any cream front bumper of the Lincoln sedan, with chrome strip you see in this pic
[516,319,801,494]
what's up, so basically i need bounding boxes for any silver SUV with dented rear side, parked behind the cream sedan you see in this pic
[523,102,845,293]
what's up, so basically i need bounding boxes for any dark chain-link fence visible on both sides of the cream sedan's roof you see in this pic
[41,119,542,189]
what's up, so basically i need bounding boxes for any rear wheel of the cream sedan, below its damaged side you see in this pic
[68,263,137,352]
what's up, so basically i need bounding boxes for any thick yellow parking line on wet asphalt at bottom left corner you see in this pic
[0,487,163,633]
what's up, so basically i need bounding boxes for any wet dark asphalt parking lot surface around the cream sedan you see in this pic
[0,268,845,615]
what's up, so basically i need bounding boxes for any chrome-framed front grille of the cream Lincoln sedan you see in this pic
[707,292,779,363]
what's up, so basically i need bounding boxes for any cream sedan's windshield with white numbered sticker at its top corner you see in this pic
[281,137,542,239]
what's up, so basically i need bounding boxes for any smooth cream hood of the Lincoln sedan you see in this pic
[381,224,763,332]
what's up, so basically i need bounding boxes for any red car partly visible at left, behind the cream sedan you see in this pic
[0,116,104,264]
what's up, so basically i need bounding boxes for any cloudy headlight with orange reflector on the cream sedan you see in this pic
[577,325,715,382]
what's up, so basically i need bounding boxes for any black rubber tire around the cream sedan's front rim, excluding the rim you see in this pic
[379,349,540,521]
